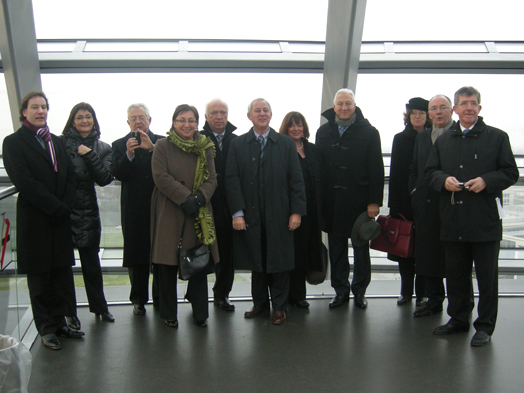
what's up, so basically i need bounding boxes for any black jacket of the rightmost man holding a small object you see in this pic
[424,116,519,242]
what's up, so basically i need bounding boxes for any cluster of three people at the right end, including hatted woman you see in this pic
[388,86,519,346]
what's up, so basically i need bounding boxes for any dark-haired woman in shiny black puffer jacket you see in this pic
[62,102,115,329]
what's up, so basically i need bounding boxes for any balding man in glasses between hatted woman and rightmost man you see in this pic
[409,95,455,317]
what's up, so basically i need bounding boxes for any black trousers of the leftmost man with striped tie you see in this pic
[27,267,72,336]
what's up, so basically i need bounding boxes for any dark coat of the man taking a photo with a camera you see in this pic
[112,131,164,267]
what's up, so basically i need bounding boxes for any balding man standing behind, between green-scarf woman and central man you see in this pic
[201,99,237,311]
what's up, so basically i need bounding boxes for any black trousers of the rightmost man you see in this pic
[444,241,500,335]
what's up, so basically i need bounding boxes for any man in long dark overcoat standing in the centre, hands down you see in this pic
[226,98,306,325]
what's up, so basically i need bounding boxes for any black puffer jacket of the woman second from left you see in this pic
[62,128,113,248]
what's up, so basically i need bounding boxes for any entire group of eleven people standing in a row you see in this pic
[3,87,518,349]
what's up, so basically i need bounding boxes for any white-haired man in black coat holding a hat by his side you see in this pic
[315,89,384,308]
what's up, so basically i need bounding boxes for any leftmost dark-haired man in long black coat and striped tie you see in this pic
[3,92,84,349]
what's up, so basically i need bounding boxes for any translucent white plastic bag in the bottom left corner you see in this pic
[0,334,32,393]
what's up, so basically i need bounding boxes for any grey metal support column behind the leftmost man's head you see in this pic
[0,0,42,130]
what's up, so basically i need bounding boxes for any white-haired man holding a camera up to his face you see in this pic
[113,104,164,315]
